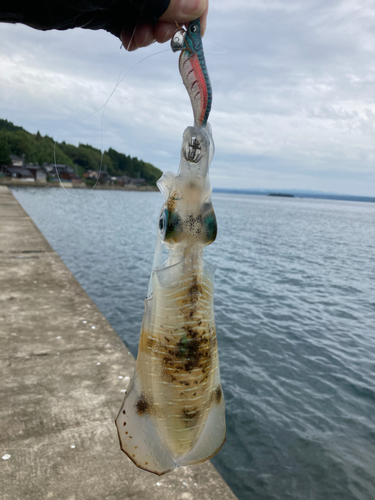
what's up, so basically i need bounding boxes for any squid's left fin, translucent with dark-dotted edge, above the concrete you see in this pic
[116,368,177,476]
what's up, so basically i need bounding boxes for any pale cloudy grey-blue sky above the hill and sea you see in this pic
[0,0,375,196]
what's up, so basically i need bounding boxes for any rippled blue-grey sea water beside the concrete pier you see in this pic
[13,188,375,500]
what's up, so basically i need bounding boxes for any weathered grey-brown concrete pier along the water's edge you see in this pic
[0,186,236,500]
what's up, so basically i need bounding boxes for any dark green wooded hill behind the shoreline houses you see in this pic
[0,119,162,185]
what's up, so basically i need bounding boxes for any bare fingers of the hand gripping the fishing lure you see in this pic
[120,0,209,51]
